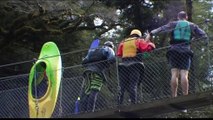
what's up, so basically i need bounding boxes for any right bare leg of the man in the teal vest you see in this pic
[180,70,189,95]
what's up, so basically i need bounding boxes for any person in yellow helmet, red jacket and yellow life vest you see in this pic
[117,29,155,105]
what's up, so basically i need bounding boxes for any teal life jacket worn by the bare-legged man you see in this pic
[173,20,191,42]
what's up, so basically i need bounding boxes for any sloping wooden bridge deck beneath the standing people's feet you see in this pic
[67,91,213,118]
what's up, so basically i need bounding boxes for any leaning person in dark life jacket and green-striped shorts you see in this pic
[80,41,115,112]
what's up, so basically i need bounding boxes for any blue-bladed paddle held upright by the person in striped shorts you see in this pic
[75,39,100,114]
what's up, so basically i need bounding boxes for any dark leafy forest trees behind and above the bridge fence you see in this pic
[0,0,213,118]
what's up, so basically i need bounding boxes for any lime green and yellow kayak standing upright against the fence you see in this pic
[28,42,62,118]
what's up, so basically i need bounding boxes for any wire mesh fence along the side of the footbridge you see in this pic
[0,38,213,118]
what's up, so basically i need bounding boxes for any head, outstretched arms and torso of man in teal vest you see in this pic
[150,11,207,45]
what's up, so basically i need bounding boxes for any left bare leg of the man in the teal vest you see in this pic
[171,68,179,98]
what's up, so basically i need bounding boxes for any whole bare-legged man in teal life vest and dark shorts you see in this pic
[148,11,208,97]
